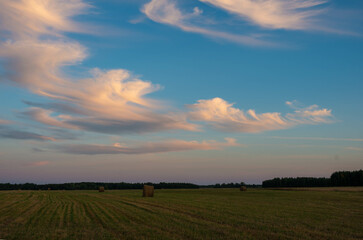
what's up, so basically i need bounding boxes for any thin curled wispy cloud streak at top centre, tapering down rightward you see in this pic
[142,0,276,46]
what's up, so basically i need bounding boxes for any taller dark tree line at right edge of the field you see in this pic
[262,170,363,188]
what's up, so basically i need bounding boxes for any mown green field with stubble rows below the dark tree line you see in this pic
[0,189,363,240]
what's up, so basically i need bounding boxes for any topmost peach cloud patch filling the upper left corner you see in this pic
[0,0,90,38]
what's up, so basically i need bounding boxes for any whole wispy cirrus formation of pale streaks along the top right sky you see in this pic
[141,0,361,47]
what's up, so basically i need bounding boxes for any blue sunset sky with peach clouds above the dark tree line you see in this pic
[0,0,363,184]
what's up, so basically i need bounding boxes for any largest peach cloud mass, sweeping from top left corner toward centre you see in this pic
[0,0,197,137]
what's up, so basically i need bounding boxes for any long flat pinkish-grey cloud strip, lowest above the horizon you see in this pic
[57,138,241,155]
